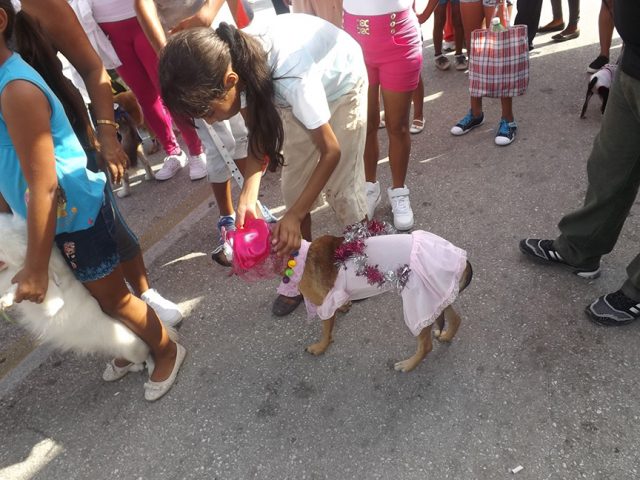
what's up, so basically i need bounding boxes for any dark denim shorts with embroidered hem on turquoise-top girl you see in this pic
[55,195,120,283]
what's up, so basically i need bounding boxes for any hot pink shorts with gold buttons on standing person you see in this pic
[343,9,422,92]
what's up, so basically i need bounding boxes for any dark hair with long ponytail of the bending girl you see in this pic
[159,23,284,170]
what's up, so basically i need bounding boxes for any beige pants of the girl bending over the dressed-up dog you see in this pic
[280,81,367,226]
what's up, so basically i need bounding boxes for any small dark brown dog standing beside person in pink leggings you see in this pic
[113,91,155,198]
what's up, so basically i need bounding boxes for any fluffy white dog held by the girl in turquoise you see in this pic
[0,213,149,363]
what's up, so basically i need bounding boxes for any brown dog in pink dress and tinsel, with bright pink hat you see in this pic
[232,220,473,372]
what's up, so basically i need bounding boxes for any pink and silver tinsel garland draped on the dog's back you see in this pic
[335,220,411,293]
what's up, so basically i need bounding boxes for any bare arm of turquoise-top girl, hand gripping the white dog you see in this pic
[0,80,58,303]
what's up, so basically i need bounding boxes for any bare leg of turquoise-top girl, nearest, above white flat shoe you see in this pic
[84,267,176,382]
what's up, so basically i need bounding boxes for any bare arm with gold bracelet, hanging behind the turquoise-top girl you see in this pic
[22,0,128,183]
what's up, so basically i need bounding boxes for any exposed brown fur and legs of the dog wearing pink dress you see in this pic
[298,235,473,372]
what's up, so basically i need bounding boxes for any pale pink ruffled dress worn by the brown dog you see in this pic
[278,230,467,336]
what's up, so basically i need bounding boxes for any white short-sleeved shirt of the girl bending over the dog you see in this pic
[256,13,367,130]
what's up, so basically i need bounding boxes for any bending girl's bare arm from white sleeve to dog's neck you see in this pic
[273,123,340,255]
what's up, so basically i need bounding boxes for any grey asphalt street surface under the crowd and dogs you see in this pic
[0,0,640,480]
